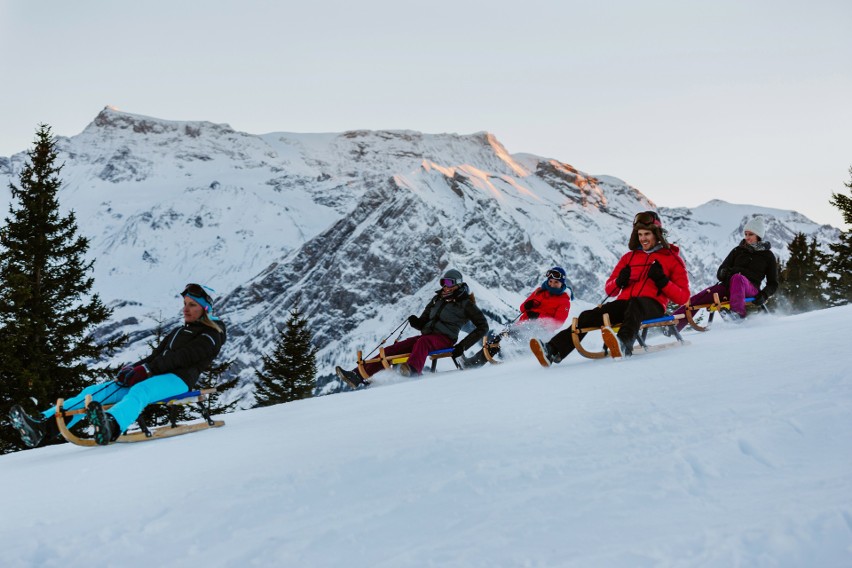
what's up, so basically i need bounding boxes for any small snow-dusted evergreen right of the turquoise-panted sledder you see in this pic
[255,300,317,407]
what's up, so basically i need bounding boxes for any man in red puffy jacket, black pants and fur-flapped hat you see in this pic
[530,211,689,367]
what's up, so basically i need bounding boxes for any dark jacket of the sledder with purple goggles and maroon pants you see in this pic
[412,284,488,349]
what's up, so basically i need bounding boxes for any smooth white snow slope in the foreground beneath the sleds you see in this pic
[0,306,852,567]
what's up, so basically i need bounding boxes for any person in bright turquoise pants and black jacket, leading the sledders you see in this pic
[9,284,225,447]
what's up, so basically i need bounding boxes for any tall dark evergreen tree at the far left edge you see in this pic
[0,125,124,451]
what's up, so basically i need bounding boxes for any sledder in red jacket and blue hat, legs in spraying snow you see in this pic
[463,266,574,367]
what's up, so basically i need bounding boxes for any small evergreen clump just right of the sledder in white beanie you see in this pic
[779,233,828,313]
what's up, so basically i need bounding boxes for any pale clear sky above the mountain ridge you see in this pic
[0,0,852,227]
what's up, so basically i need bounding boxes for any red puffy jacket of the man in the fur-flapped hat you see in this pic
[604,245,689,309]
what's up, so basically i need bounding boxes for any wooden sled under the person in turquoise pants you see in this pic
[56,388,225,446]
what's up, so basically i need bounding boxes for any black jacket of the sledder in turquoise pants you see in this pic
[134,319,226,390]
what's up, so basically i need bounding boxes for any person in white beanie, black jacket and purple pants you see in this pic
[674,217,778,331]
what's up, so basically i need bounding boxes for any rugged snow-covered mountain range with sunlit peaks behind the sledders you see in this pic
[0,108,838,400]
